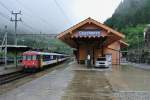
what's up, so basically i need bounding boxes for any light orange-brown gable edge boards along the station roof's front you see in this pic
[57,17,125,39]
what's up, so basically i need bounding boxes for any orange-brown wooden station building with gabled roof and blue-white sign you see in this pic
[57,18,128,64]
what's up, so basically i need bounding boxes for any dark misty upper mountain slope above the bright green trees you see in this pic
[105,0,150,30]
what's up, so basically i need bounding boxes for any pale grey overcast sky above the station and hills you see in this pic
[0,0,122,34]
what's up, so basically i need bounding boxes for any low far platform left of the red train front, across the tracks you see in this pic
[0,64,22,75]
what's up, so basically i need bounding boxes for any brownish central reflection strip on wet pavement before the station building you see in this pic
[62,65,113,100]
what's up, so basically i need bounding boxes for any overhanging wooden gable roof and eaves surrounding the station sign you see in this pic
[57,17,128,48]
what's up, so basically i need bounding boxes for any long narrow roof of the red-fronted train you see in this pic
[23,51,63,55]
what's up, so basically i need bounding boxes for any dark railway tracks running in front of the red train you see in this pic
[0,71,29,85]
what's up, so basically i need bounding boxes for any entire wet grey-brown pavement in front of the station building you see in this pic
[0,62,150,100]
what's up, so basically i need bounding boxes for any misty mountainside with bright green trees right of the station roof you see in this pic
[105,0,150,47]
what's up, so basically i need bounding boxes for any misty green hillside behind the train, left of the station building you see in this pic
[0,32,72,55]
